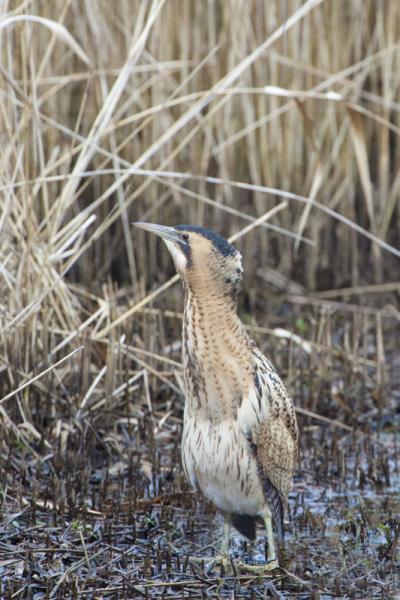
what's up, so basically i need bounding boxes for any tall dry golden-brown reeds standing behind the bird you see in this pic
[0,0,400,444]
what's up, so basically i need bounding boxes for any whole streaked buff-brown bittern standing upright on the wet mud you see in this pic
[135,223,297,570]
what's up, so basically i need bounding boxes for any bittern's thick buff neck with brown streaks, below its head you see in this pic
[183,282,252,422]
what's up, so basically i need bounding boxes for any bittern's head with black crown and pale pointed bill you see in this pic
[134,222,243,297]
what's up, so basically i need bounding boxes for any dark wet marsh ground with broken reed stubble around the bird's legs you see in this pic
[0,312,400,600]
